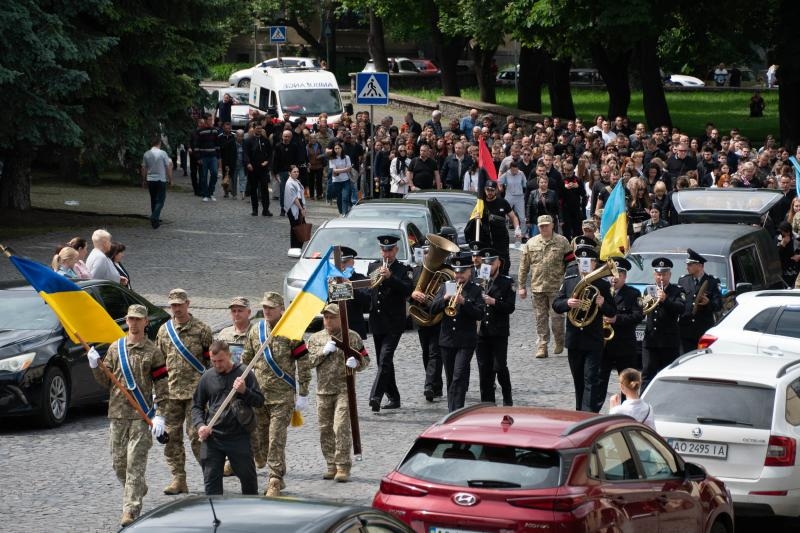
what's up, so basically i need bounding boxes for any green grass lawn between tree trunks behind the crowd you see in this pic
[398,87,779,145]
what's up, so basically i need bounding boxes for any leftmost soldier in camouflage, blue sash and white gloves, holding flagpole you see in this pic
[89,305,167,526]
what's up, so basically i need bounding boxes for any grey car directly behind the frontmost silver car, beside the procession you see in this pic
[347,198,454,241]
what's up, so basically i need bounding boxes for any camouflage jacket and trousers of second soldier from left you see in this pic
[156,316,213,480]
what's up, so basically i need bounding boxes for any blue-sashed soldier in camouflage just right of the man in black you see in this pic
[242,292,311,496]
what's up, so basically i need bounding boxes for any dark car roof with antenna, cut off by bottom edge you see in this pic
[122,494,413,533]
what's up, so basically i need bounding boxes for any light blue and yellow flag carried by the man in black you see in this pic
[271,246,343,340]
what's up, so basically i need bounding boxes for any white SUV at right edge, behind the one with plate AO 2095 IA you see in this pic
[698,290,800,359]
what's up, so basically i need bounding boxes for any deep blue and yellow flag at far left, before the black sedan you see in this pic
[9,255,125,344]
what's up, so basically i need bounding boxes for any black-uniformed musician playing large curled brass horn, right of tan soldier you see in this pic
[553,247,616,413]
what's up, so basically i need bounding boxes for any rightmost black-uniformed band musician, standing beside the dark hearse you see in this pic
[678,248,722,353]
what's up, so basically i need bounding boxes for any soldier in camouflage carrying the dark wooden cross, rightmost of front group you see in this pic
[308,304,369,482]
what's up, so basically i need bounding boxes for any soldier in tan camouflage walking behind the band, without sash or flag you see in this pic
[518,215,572,358]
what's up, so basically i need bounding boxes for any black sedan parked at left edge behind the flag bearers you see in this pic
[0,280,169,427]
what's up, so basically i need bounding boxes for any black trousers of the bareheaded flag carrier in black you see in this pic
[200,433,258,495]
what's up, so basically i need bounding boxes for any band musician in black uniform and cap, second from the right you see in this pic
[642,257,686,390]
